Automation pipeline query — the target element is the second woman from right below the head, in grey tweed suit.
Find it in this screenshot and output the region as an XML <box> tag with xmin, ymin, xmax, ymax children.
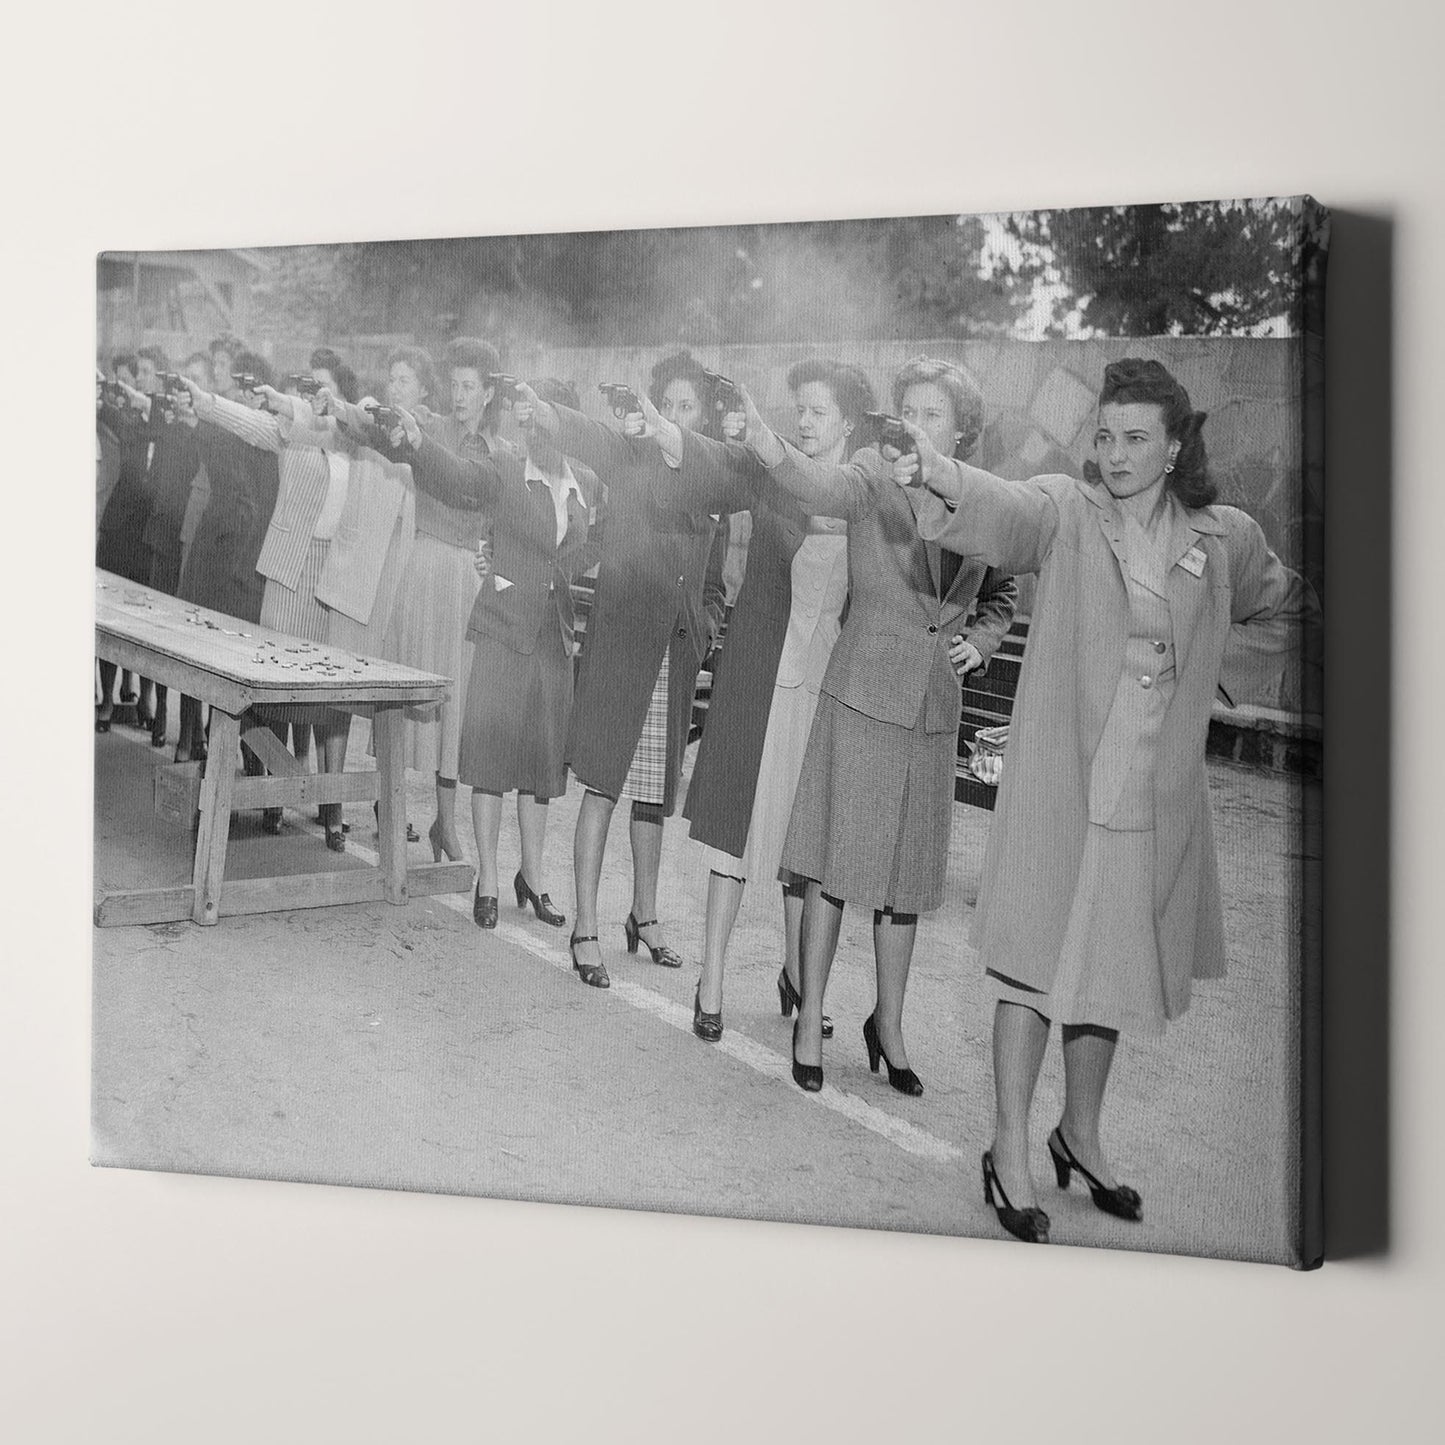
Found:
<box><xmin>743</xmin><ymin>369</ymin><xmax>1012</xmax><ymax>1094</ymax></box>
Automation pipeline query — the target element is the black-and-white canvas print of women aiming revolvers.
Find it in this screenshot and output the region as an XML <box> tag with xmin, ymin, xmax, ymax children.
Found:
<box><xmin>92</xmin><ymin>197</ymin><xmax>1328</xmax><ymax>1266</ymax></box>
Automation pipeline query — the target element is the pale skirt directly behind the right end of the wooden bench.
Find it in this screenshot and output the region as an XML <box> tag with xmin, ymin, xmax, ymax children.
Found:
<box><xmin>381</xmin><ymin>532</ymin><xmax>481</xmax><ymax>777</ymax></box>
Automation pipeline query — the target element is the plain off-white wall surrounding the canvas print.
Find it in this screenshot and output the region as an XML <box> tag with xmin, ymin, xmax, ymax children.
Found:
<box><xmin>14</xmin><ymin>0</ymin><xmax>1445</xmax><ymax>1445</ymax></box>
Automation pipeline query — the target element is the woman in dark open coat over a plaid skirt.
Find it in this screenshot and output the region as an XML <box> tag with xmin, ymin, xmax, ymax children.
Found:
<box><xmin>516</xmin><ymin>355</ymin><xmax>737</xmax><ymax>988</ymax></box>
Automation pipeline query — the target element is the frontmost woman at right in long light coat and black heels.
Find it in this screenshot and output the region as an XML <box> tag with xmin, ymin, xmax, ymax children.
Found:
<box><xmin>894</xmin><ymin>358</ymin><xmax>1314</xmax><ymax>1243</ymax></box>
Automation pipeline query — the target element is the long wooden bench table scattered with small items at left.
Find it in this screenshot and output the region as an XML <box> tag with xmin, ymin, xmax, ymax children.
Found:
<box><xmin>95</xmin><ymin>572</ymin><xmax>473</xmax><ymax>926</ymax></box>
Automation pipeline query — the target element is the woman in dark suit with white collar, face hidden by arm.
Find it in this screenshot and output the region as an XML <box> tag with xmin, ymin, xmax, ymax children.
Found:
<box><xmin>390</xmin><ymin>383</ymin><xmax>598</xmax><ymax>928</ymax></box>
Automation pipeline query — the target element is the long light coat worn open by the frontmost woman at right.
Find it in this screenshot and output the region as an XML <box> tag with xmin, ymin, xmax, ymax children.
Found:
<box><xmin>916</xmin><ymin>462</ymin><xmax>1318</xmax><ymax>1017</ymax></box>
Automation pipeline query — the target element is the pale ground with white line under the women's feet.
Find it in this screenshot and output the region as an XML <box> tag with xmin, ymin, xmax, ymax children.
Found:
<box><xmin>84</xmin><ymin>713</ymin><xmax>1301</xmax><ymax>1261</ymax></box>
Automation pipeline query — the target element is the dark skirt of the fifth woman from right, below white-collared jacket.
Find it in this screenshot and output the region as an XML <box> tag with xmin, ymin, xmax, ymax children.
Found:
<box><xmin>458</xmin><ymin>627</ymin><xmax>572</xmax><ymax>801</ymax></box>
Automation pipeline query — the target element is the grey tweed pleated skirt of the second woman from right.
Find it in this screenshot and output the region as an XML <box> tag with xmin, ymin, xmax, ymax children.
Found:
<box><xmin>782</xmin><ymin>692</ymin><xmax>958</xmax><ymax>913</ymax></box>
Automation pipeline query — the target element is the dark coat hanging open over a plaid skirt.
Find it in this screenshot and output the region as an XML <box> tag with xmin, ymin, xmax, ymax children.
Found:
<box><xmin>555</xmin><ymin>406</ymin><xmax>737</xmax><ymax>814</ymax></box>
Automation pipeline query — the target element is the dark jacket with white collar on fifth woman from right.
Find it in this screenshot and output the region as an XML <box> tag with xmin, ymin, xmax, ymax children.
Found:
<box><xmin>412</xmin><ymin>434</ymin><xmax>598</xmax><ymax>657</ymax></box>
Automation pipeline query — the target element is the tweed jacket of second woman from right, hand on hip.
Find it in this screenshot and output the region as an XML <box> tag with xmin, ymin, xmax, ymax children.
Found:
<box><xmin>772</xmin><ymin>442</ymin><xmax>1013</xmax><ymax>733</ymax></box>
